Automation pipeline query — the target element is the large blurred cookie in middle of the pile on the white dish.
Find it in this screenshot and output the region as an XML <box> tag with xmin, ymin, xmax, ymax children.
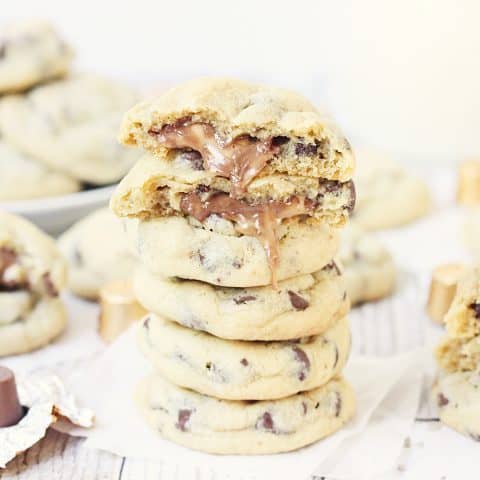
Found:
<box><xmin>0</xmin><ymin>74</ymin><xmax>137</xmax><ymax>185</ymax></box>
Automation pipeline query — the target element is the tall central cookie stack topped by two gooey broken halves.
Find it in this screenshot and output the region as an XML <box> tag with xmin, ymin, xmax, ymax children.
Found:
<box><xmin>111</xmin><ymin>79</ymin><xmax>355</xmax><ymax>454</ymax></box>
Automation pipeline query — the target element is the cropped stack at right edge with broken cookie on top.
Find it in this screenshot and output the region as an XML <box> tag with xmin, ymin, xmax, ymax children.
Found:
<box><xmin>433</xmin><ymin>267</ymin><xmax>480</xmax><ymax>441</ymax></box>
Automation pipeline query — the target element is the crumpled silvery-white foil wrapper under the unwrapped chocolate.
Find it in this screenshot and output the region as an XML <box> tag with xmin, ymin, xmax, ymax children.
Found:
<box><xmin>0</xmin><ymin>375</ymin><xmax>95</xmax><ymax>468</ymax></box>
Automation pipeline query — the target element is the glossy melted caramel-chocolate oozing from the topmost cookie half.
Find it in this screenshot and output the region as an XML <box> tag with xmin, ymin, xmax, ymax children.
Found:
<box><xmin>150</xmin><ymin>124</ymin><xmax>280</xmax><ymax>198</ymax></box>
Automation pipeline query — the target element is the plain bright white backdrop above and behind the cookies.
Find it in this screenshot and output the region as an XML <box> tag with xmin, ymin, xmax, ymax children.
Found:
<box><xmin>0</xmin><ymin>0</ymin><xmax>480</xmax><ymax>163</ymax></box>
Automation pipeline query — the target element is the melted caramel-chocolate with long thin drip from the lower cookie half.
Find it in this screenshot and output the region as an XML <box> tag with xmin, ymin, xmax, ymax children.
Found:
<box><xmin>180</xmin><ymin>192</ymin><xmax>314</xmax><ymax>288</ymax></box>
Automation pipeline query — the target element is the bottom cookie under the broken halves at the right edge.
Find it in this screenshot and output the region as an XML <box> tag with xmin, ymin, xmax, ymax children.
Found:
<box><xmin>433</xmin><ymin>370</ymin><xmax>480</xmax><ymax>442</ymax></box>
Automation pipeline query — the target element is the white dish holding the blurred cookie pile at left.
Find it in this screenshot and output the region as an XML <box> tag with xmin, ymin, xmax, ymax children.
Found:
<box><xmin>0</xmin><ymin>185</ymin><xmax>116</xmax><ymax>235</ymax></box>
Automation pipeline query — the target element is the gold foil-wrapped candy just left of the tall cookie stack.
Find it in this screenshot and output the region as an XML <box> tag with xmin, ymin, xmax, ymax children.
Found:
<box><xmin>98</xmin><ymin>281</ymin><xmax>147</xmax><ymax>343</ymax></box>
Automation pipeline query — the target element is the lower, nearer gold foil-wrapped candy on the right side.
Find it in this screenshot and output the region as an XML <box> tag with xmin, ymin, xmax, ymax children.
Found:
<box><xmin>427</xmin><ymin>263</ymin><xmax>465</xmax><ymax>324</ymax></box>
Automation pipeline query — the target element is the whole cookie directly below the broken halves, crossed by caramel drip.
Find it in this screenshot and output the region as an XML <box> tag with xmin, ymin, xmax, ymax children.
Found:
<box><xmin>124</xmin><ymin>215</ymin><xmax>339</xmax><ymax>287</ymax></box>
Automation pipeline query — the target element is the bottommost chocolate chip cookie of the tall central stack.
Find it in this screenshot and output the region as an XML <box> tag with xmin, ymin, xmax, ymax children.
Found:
<box><xmin>137</xmin><ymin>375</ymin><xmax>355</xmax><ymax>455</ymax></box>
